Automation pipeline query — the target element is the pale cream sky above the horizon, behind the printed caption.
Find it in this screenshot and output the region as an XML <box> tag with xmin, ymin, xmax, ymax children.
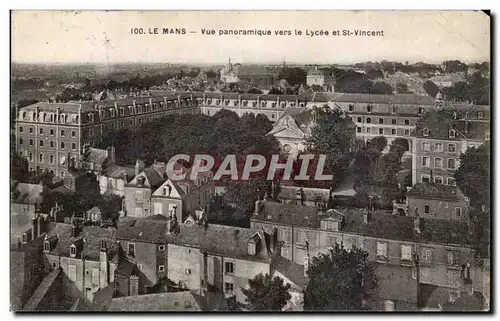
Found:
<box><xmin>11</xmin><ymin>10</ymin><xmax>490</xmax><ymax>64</ymax></box>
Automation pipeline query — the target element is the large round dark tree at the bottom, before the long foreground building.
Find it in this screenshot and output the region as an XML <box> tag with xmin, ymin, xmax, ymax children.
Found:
<box><xmin>304</xmin><ymin>244</ymin><xmax>377</xmax><ymax>311</ymax></box>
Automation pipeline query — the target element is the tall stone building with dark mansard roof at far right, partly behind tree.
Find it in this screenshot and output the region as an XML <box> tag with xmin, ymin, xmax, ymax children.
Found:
<box><xmin>411</xmin><ymin>105</ymin><xmax>491</xmax><ymax>185</ymax></box>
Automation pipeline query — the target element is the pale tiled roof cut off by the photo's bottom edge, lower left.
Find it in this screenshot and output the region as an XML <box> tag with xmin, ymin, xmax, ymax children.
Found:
<box><xmin>107</xmin><ymin>291</ymin><xmax>202</xmax><ymax>312</ymax></box>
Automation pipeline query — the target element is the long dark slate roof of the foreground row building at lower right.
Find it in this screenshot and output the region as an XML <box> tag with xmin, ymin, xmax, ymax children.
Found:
<box><xmin>250</xmin><ymin>201</ymin><xmax>472</xmax><ymax>245</ymax></box>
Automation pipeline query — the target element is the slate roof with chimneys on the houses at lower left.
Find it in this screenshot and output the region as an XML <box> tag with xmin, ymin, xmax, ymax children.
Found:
<box><xmin>47</xmin><ymin>222</ymin><xmax>119</xmax><ymax>261</ymax></box>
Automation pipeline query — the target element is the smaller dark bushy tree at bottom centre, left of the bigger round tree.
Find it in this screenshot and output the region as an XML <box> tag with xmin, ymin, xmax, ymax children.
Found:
<box><xmin>241</xmin><ymin>273</ymin><xmax>291</xmax><ymax>311</ymax></box>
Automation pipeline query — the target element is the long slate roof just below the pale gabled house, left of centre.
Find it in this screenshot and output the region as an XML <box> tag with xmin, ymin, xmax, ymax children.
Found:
<box><xmin>117</xmin><ymin>219</ymin><xmax>270</xmax><ymax>261</ymax></box>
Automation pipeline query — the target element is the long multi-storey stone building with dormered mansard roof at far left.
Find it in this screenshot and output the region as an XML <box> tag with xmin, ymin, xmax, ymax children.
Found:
<box><xmin>15</xmin><ymin>94</ymin><xmax>199</xmax><ymax>178</ymax></box>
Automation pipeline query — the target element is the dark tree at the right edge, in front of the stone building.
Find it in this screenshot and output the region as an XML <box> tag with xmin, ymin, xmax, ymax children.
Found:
<box><xmin>455</xmin><ymin>145</ymin><xmax>491</xmax><ymax>208</ymax></box>
